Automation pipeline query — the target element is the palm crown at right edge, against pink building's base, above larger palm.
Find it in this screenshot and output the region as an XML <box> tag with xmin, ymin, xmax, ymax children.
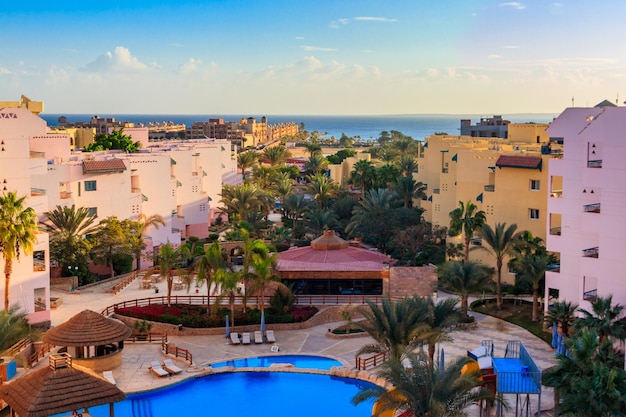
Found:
<box><xmin>574</xmin><ymin>295</ymin><xmax>626</xmax><ymax>342</ymax></box>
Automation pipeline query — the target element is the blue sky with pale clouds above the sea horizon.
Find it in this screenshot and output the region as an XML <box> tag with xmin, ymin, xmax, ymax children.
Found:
<box><xmin>0</xmin><ymin>0</ymin><xmax>626</xmax><ymax>115</ymax></box>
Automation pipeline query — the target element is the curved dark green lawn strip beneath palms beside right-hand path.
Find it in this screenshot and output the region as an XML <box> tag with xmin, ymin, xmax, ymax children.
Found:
<box><xmin>472</xmin><ymin>299</ymin><xmax>552</xmax><ymax>344</ymax></box>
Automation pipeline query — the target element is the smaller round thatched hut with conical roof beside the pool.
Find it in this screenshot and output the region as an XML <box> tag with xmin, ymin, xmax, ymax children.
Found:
<box><xmin>43</xmin><ymin>310</ymin><xmax>133</xmax><ymax>359</ymax></box>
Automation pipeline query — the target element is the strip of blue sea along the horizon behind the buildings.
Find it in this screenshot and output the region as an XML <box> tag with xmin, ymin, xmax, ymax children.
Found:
<box><xmin>40</xmin><ymin>113</ymin><xmax>558</xmax><ymax>141</ymax></box>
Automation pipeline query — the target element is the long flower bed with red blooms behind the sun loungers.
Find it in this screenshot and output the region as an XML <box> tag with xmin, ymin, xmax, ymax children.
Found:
<box><xmin>115</xmin><ymin>304</ymin><xmax>318</xmax><ymax>328</ymax></box>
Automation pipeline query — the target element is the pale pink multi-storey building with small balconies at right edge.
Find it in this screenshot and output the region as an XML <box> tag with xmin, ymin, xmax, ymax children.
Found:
<box><xmin>545</xmin><ymin>102</ymin><xmax>626</xmax><ymax>309</ymax></box>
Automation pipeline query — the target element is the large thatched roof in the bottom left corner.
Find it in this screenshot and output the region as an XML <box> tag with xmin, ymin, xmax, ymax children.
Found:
<box><xmin>0</xmin><ymin>354</ymin><xmax>126</xmax><ymax>417</ymax></box>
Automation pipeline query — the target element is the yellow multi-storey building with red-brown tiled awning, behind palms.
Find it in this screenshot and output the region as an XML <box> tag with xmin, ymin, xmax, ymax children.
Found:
<box><xmin>416</xmin><ymin>123</ymin><xmax>562</xmax><ymax>283</ymax></box>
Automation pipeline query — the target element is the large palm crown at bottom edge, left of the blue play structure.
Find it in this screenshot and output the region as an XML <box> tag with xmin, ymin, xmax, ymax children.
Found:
<box><xmin>352</xmin><ymin>353</ymin><xmax>495</xmax><ymax>417</ymax></box>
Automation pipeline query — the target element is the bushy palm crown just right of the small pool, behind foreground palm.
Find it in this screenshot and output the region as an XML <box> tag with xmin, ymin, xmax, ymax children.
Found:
<box><xmin>352</xmin><ymin>297</ymin><xmax>430</xmax><ymax>360</ymax></box>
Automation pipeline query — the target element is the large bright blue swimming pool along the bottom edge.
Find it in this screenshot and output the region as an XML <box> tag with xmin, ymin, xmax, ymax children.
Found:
<box><xmin>66</xmin><ymin>372</ymin><xmax>373</xmax><ymax>417</ymax></box>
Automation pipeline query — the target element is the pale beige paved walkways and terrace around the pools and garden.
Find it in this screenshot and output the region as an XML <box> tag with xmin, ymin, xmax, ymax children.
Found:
<box><xmin>51</xmin><ymin>274</ymin><xmax>556</xmax><ymax>412</ymax></box>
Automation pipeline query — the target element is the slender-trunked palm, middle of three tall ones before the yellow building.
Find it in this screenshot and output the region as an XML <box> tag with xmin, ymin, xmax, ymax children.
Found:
<box><xmin>478</xmin><ymin>223</ymin><xmax>521</xmax><ymax>310</ymax></box>
